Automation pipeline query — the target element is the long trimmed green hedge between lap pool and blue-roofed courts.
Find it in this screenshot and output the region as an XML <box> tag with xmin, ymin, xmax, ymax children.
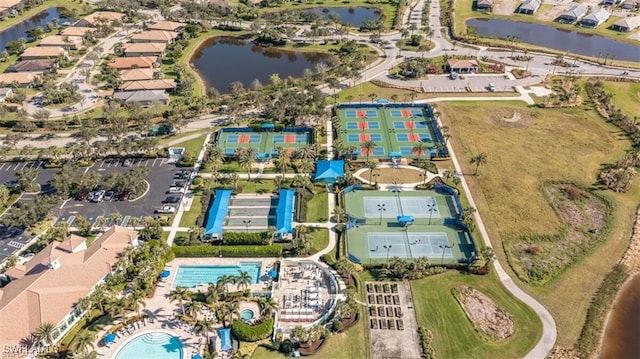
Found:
<box><xmin>173</xmin><ymin>244</ymin><xmax>282</xmax><ymax>257</ymax></box>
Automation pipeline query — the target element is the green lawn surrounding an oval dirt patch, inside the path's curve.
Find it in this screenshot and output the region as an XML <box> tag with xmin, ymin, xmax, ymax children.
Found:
<box><xmin>411</xmin><ymin>271</ymin><xmax>542</xmax><ymax>358</ymax></box>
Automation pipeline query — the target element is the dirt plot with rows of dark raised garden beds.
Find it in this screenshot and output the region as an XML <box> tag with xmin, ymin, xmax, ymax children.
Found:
<box><xmin>366</xmin><ymin>282</ymin><xmax>422</xmax><ymax>359</ymax></box>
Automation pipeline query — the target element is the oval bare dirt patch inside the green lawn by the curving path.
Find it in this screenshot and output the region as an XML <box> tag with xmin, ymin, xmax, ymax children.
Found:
<box><xmin>455</xmin><ymin>286</ymin><xmax>514</xmax><ymax>340</ymax></box>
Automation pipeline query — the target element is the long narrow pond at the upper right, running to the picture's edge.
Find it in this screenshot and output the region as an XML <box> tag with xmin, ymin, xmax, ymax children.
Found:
<box><xmin>466</xmin><ymin>19</ymin><xmax>640</xmax><ymax>62</ymax></box>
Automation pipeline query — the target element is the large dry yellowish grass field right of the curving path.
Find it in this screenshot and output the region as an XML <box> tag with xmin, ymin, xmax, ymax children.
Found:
<box><xmin>438</xmin><ymin>93</ymin><xmax>640</xmax><ymax>347</ymax></box>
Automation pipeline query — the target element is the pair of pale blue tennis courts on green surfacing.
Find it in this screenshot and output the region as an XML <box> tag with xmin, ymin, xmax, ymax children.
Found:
<box><xmin>344</xmin><ymin>191</ymin><xmax>474</xmax><ymax>264</ymax></box>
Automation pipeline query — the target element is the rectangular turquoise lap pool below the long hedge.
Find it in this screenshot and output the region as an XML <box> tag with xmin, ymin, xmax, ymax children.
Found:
<box><xmin>173</xmin><ymin>262</ymin><xmax>262</xmax><ymax>288</ymax></box>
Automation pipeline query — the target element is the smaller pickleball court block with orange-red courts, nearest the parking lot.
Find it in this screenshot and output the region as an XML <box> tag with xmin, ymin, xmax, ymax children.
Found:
<box><xmin>216</xmin><ymin>128</ymin><xmax>312</xmax><ymax>159</ymax></box>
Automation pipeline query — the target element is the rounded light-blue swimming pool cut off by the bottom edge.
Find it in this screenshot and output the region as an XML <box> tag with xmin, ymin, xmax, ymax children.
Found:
<box><xmin>113</xmin><ymin>330</ymin><xmax>184</xmax><ymax>359</ymax></box>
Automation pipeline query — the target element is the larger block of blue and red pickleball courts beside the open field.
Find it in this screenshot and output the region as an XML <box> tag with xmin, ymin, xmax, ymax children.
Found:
<box><xmin>337</xmin><ymin>104</ymin><xmax>448</xmax><ymax>158</ymax></box>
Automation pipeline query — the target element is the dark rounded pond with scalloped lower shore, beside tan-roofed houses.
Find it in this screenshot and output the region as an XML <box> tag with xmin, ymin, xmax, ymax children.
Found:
<box><xmin>191</xmin><ymin>37</ymin><xmax>329</xmax><ymax>93</ymax></box>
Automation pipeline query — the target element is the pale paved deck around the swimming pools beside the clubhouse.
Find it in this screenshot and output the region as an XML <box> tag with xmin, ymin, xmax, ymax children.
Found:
<box><xmin>95</xmin><ymin>258</ymin><xmax>276</xmax><ymax>359</ymax></box>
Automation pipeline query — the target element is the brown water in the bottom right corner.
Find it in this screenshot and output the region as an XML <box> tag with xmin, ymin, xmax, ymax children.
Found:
<box><xmin>600</xmin><ymin>275</ymin><xmax>640</xmax><ymax>359</ymax></box>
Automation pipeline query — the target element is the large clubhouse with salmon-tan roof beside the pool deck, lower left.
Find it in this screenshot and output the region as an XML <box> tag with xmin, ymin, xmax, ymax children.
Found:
<box><xmin>0</xmin><ymin>226</ymin><xmax>138</xmax><ymax>345</ymax></box>
